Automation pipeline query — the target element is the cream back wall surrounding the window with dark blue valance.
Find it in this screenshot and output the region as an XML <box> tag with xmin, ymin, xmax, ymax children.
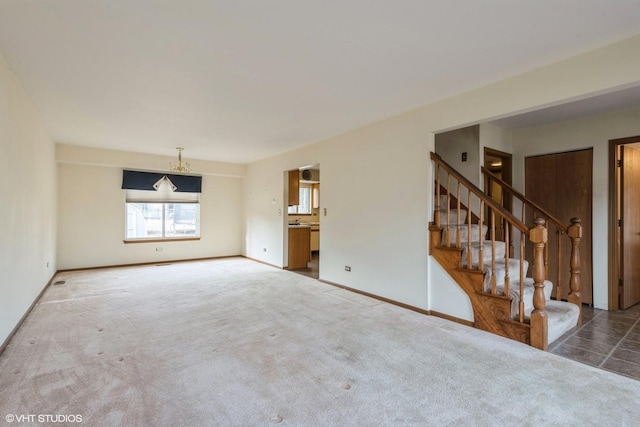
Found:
<box><xmin>57</xmin><ymin>145</ymin><xmax>245</xmax><ymax>270</ymax></box>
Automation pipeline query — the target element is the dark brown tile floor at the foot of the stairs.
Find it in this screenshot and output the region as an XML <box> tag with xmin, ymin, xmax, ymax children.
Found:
<box><xmin>549</xmin><ymin>304</ymin><xmax>640</xmax><ymax>380</ymax></box>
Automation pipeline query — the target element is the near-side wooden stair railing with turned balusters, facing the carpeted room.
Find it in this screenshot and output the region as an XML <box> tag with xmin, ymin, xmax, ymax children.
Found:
<box><xmin>430</xmin><ymin>152</ymin><xmax>547</xmax><ymax>328</ymax></box>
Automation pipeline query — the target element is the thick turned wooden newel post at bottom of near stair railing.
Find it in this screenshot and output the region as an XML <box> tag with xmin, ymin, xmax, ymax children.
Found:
<box><xmin>529</xmin><ymin>218</ymin><xmax>549</xmax><ymax>351</ymax></box>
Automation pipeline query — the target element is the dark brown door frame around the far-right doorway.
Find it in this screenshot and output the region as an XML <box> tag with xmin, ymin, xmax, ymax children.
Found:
<box><xmin>608</xmin><ymin>135</ymin><xmax>640</xmax><ymax>311</ymax></box>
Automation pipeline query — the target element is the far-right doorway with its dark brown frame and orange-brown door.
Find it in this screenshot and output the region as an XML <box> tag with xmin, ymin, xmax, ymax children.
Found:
<box><xmin>609</xmin><ymin>136</ymin><xmax>640</xmax><ymax>310</ymax></box>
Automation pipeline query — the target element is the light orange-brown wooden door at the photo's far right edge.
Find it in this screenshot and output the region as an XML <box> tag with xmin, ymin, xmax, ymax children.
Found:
<box><xmin>620</xmin><ymin>145</ymin><xmax>640</xmax><ymax>309</ymax></box>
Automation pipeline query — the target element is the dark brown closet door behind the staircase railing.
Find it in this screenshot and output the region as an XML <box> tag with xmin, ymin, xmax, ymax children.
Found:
<box><xmin>525</xmin><ymin>149</ymin><xmax>593</xmax><ymax>304</ymax></box>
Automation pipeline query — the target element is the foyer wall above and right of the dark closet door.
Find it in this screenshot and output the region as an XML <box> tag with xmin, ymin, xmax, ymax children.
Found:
<box><xmin>513</xmin><ymin>105</ymin><xmax>640</xmax><ymax>309</ymax></box>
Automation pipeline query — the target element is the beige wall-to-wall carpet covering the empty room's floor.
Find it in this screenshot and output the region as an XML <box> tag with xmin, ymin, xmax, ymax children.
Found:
<box><xmin>0</xmin><ymin>258</ymin><xmax>640</xmax><ymax>426</ymax></box>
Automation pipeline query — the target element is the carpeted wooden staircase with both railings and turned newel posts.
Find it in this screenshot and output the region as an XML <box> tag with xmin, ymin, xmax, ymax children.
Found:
<box><xmin>429</xmin><ymin>153</ymin><xmax>582</xmax><ymax>350</ymax></box>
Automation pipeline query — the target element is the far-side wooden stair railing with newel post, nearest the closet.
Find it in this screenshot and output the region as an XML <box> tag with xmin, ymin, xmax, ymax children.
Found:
<box><xmin>481</xmin><ymin>166</ymin><xmax>582</xmax><ymax>324</ymax></box>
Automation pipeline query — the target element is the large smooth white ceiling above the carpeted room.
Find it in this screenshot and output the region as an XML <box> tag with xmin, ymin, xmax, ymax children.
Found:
<box><xmin>0</xmin><ymin>0</ymin><xmax>640</xmax><ymax>163</ymax></box>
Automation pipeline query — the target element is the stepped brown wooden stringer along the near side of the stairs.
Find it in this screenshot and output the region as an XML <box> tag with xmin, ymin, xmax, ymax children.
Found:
<box><xmin>431</xmin><ymin>247</ymin><xmax>531</xmax><ymax>345</ymax></box>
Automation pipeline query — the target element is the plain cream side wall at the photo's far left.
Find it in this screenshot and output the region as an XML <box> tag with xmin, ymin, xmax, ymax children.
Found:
<box><xmin>0</xmin><ymin>55</ymin><xmax>56</xmax><ymax>345</ymax></box>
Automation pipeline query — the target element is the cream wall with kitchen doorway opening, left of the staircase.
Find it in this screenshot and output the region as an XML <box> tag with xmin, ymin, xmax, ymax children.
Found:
<box><xmin>245</xmin><ymin>116</ymin><xmax>429</xmax><ymax>307</ymax></box>
